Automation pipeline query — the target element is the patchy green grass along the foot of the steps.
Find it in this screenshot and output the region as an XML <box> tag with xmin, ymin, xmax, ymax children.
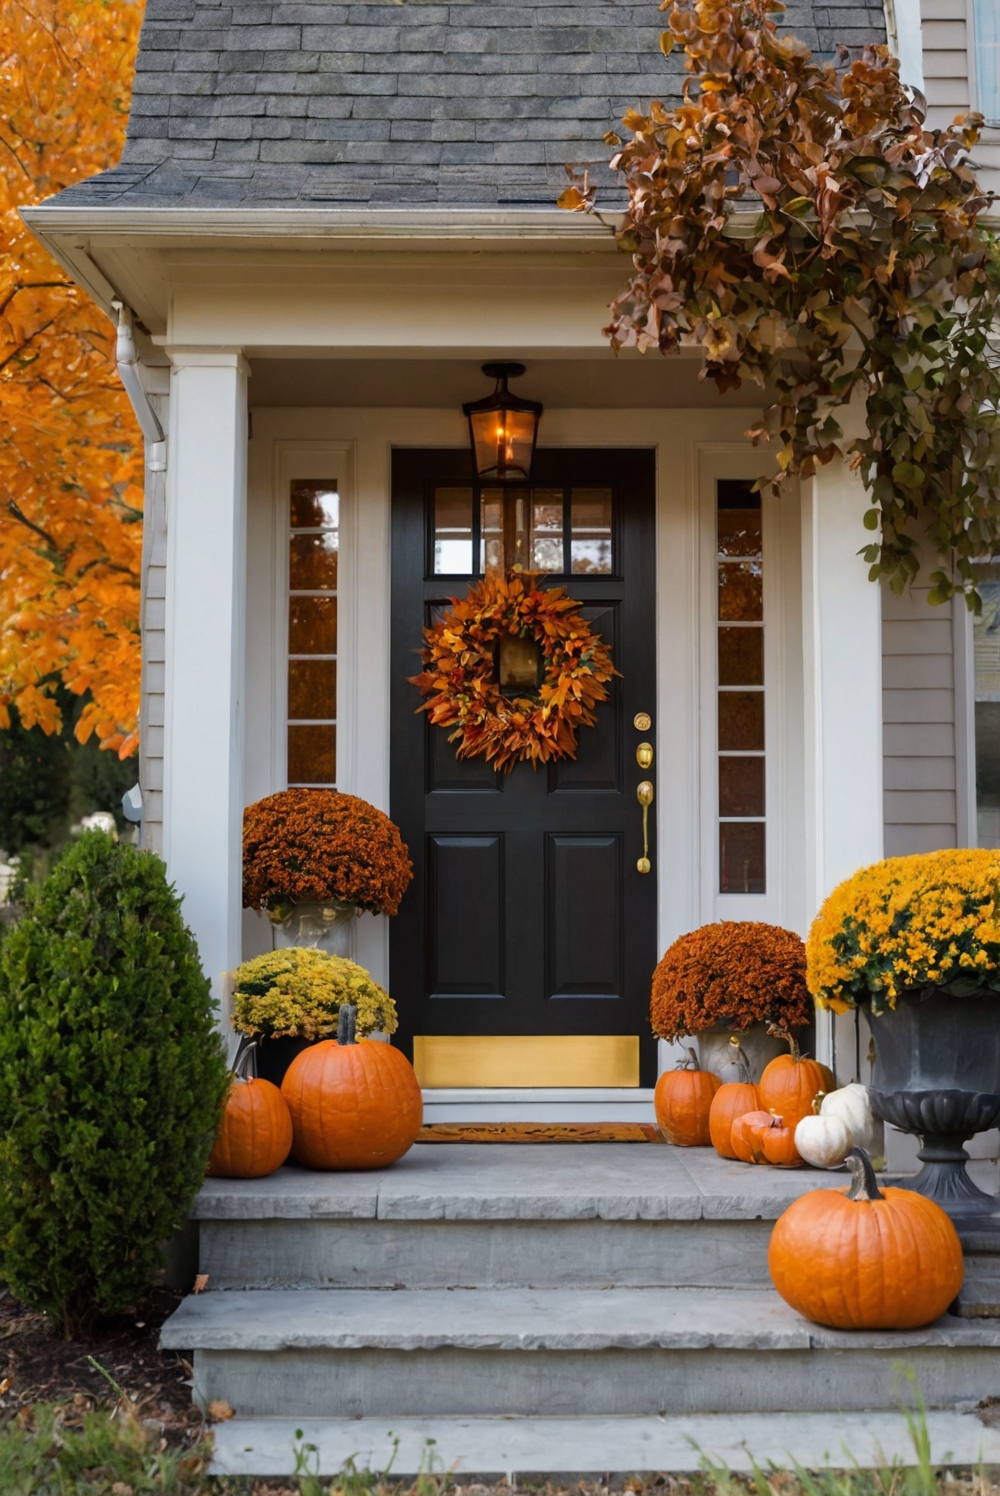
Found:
<box><xmin>0</xmin><ymin>1388</ymin><xmax>1000</xmax><ymax>1496</ymax></box>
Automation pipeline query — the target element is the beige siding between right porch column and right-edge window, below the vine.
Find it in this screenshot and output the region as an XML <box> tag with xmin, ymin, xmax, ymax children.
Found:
<box><xmin>882</xmin><ymin>588</ymin><xmax>958</xmax><ymax>857</ymax></box>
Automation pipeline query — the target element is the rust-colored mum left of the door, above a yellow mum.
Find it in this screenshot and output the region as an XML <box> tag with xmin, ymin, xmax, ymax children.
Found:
<box><xmin>243</xmin><ymin>790</ymin><xmax>413</xmax><ymax>914</ymax></box>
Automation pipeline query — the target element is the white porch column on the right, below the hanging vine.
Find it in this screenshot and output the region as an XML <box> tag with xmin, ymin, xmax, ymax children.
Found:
<box><xmin>802</xmin><ymin>459</ymin><xmax>883</xmax><ymax>1083</ymax></box>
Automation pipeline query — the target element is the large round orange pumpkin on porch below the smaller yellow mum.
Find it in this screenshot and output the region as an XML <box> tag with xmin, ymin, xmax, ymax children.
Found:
<box><xmin>281</xmin><ymin>1004</ymin><xmax>424</xmax><ymax>1168</ymax></box>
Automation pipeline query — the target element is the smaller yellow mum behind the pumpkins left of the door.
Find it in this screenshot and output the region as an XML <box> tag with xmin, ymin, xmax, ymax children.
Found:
<box><xmin>232</xmin><ymin>945</ymin><xmax>398</xmax><ymax>1040</ymax></box>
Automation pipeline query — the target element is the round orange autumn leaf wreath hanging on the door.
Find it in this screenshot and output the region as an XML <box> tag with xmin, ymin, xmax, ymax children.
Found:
<box><xmin>409</xmin><ymin>571</ymin><xmax>618</xmax><ymax>773</ymax></box>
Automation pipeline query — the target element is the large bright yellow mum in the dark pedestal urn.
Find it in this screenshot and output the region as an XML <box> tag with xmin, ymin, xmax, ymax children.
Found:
<box><xmin>805</xmin><ymin>848</ymin><xmax>1000</xmax><ymax>1013</ymax></box>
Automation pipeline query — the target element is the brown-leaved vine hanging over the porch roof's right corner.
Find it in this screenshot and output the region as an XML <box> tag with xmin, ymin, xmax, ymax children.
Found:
<box><xmin>560</xmin><ymin>0</ymin><xmax>1000</xmax><ymax>606</ymax></box>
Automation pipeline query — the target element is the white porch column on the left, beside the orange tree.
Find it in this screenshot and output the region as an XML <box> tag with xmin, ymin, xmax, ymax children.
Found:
<box><xmin>163</xmin><ymin>349</ymin><xmax>249</xmax><ymax>1020</ymax></box>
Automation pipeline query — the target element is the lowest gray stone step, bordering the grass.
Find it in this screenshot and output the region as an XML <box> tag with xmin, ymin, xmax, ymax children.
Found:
<box><xmin>211</xmin><ymin>1411</ymin><xmax>1000</xmax><ymax>1484</ymax></box>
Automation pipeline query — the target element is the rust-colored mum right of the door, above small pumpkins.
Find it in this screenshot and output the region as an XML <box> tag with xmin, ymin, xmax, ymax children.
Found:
<box><xmin>650</xmin><ymin>920</ymin><xmax>813</xmax><ymax>1040</ymax></box>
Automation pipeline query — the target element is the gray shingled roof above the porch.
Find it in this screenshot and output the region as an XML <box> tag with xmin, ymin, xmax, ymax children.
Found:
<box><xmin>50</xmin><ymin>0</ymin><xmax>885</xmax><ymax>208</ymax></box>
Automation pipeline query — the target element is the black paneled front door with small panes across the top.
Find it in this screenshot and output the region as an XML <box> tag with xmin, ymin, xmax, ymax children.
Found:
<box><xmin>391</xmin><ymin>449</ymin><xmax>656</xmax><ymax>1085</ymax></box>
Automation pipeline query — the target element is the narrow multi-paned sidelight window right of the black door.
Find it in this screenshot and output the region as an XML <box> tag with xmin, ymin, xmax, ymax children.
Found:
<box><xmin>716</xmin><ymin>479</ymin><xmax>766</xmax><ymax>893</ymax></box>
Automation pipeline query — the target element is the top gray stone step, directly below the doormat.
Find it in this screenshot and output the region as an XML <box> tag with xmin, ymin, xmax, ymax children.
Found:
<box><xmin>195</xmin><ymin>1144</ymin><xmax>843</xmax><ymax>1288</ymax></box>
